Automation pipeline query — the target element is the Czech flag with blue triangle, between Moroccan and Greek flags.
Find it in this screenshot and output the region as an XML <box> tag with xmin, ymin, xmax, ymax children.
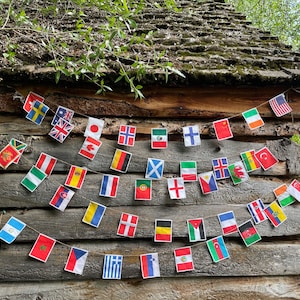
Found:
<box><xmin>64</xmin><ymin>247</ymin><xmax>88</xmax><ymax>275</ymax></box>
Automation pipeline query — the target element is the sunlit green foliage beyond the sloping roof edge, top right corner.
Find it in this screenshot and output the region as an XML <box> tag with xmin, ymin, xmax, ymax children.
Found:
<box><xmin>226</xmin><ymin>0</ymin><xmax>300</xmax><ymax>50</ymax></box>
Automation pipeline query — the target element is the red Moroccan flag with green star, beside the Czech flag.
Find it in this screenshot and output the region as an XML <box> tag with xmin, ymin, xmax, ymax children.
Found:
<box><xmin>29</xmin><ymin>233</ymin><xmax>56</xmax><ymax>262</ymax></box>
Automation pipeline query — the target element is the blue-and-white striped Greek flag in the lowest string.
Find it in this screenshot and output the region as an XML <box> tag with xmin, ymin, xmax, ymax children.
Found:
<box><xmin>102</xmin><ymin>254</ymin><xmax>123</xmax><ymax>279</ymax></box>
